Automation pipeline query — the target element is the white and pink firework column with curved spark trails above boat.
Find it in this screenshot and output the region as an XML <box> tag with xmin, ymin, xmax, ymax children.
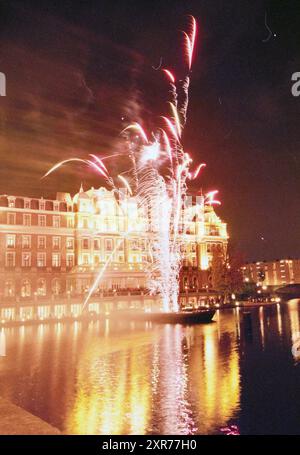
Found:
<box><xmin>45</xmin><ymin>17</ymin><xmax>211</xmax><ymax>311</ymax></box>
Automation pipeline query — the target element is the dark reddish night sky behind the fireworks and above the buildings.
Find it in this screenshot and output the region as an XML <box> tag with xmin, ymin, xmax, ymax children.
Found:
<box><xmin>0</xmin><ymin>0</ymin><xmax>300</xmax><ymax>260</ymax></box>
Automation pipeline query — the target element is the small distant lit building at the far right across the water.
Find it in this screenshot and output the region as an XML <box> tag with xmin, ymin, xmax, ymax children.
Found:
<box><xmin>242</xmin><ymin>259</ymin><xmax>300</xmax><ymax>287</ymax></box>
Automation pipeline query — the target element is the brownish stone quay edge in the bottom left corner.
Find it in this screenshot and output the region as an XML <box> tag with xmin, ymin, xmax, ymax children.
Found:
<box><xmin>0</xmin><ymin>398</ymin><xmax>61</xmax><ymax>435</ymax></box>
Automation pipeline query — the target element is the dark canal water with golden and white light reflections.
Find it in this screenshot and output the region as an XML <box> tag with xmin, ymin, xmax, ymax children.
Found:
<box><xmin>0</xmin><ymin>300</ymin><xmax>300</xmax><ymax>434</ymax></box>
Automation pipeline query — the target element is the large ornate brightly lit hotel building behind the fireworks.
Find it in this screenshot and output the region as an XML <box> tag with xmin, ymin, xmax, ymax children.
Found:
<box><xmin>0</xmin><ymin>188</ymin><xmax>227</xmax><ymax>301</ymax></box>
